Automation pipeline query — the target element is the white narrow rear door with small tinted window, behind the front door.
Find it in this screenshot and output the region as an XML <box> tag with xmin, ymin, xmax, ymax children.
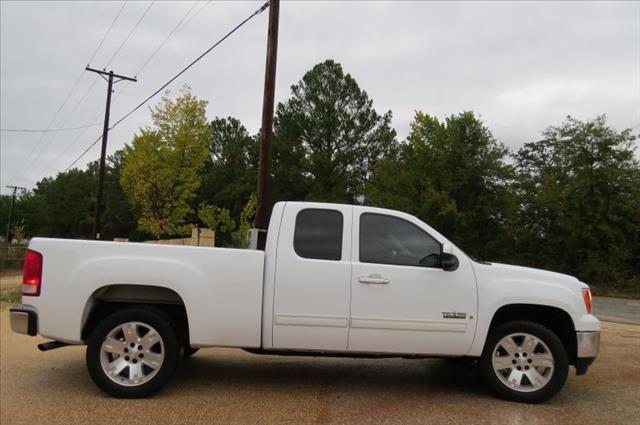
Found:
<box><xmin>273</xmin><ymin>202</ymin><xmax>353</xmax><ymax>351</ymax></box>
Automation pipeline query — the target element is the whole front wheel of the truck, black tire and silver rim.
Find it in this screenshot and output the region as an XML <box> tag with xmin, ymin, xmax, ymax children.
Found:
<box><xmin>480</xmin><ymin>321</ymin><xmax>569</xmax><ymax>403</ymax></box>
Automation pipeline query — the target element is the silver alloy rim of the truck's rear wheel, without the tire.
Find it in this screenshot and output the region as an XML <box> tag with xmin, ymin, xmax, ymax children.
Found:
<box><xmin>100</xmin><ymin>322</ymin><xmax>165</xmax><ymax>387</ymax></box>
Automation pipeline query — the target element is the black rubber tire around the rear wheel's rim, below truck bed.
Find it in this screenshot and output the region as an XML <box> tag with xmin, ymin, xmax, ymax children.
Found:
<box><xmin>86</xmin><ymin>307</ymin><xmax>180</xmax><ymax>398</ymax></box>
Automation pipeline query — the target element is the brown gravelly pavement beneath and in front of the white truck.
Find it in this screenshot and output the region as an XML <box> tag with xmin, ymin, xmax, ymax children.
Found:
<box><xmin>0</xmin><ymin>306</ymin><xmax>640</xmax><ymax>425</ymax></box>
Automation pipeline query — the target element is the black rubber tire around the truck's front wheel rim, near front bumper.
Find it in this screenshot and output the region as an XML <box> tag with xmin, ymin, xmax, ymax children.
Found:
<box><xmin>480</xmin><ymin>321</ymin><xmax>569</xmax><ymax>403</ymax></box>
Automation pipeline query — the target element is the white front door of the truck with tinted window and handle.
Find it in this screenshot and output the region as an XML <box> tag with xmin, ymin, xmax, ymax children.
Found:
<box><xmin>348</xmin><ymin>207</ymin><xmax>477</xmax><ymax>355</ymax></box>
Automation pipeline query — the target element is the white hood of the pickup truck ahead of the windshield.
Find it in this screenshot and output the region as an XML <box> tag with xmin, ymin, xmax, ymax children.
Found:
<box><xmin>473</xmin><ymin>263</ymin><xmax>587</xmax><ymax>289</ymax></box>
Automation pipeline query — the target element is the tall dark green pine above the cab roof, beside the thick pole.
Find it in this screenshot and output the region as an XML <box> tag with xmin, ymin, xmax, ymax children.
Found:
<box><xmin>273</xmin><ymin>60</ymin><xmax>396</xmax><ymax>203</ymax></box>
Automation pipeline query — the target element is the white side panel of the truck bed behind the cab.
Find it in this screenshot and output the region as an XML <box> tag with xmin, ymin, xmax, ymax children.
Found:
<box><xmin>23</xmin><ymin>238</ymin><xmax>264</xmax><ymax>347</ymax></box>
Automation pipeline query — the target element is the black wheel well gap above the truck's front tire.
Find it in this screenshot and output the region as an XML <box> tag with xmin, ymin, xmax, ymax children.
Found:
<box><xmin>485</xmin><ymin>304</ymin><xmax>577</xmax><ymax>365</ymax></box>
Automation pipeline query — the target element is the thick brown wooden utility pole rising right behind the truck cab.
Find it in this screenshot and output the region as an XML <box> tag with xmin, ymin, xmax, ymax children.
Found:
<box><xmin>256</xmin><ymin>0</ymin><xmax>280</xmax><ymax>250</ymax></box>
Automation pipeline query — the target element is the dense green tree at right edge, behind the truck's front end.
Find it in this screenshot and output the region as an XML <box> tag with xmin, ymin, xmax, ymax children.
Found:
<box><xmin>514</xmin><ymin>115</ymin><xmax>640</xmax><ymax>291</ymax></box>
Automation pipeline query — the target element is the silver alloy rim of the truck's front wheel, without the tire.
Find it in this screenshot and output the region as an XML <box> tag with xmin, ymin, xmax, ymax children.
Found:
<box><xmin>491</xmin><ymin>333</ymin><xmax>554</xmax><ymax>392</ymax></box>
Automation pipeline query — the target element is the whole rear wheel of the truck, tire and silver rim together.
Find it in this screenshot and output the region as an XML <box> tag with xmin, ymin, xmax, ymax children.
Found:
<box><xmin>86</xmin><ymin>308</ymin><xmax>180</xmax><ymax>398</ymax></box>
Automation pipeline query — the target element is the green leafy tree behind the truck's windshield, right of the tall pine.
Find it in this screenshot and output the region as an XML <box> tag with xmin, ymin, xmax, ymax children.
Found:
<box><xmin>366</xmin><ymin>112</ymin><xmax>515</xmax><ymax>259</ymax></box>
